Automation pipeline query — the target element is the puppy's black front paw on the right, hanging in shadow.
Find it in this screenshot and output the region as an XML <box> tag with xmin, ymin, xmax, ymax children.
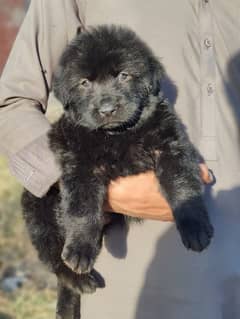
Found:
<box><xmin>176</xmin><ymin>202</ymin><xmax>213</xmax><ymax>252</ymax></box>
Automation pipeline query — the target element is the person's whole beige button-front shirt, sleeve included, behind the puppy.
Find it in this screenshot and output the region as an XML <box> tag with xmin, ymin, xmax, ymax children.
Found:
<box><xmin>0</xmin><ymin>0</ymin><xmax>240</xmax><ymax>319</ymax></box>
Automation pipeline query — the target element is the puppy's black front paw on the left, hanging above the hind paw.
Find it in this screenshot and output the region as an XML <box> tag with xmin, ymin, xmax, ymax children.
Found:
<box><xmin>61</xmin><ymin>241</ymin><xmax>97</xmax><ymax>274</ymax></box>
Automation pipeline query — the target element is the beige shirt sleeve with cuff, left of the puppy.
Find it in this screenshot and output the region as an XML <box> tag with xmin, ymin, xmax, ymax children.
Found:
<box><xmin>0</xmin><ymin>0</ymin><xmax>83</xmax><ymax>197</ymax></box>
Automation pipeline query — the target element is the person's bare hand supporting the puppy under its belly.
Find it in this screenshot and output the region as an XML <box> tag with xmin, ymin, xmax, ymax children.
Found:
<box><xmin>104</xmin><ymin>164</ymin><xmax>213</xmax><ymax>221</ymax></box>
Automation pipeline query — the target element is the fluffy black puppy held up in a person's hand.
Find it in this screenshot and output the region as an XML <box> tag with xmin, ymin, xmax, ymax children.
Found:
<box><xmin>22</xmin><ymin>26</ymin><xmax>213</xmax><ymax>302</ymax></box>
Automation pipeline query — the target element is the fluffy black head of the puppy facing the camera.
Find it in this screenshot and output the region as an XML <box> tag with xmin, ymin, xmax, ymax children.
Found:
<box><xmin>53</xmin><ymin>26</ymin><xmax>164</xmax><ymax>131</ymax></box>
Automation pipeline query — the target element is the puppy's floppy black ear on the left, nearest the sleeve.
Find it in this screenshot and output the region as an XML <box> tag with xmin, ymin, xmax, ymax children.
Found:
<box><xmin>52</xmin><ymin>64</ymin><xmax>69</xmax><ymax>110</ymax></box>
